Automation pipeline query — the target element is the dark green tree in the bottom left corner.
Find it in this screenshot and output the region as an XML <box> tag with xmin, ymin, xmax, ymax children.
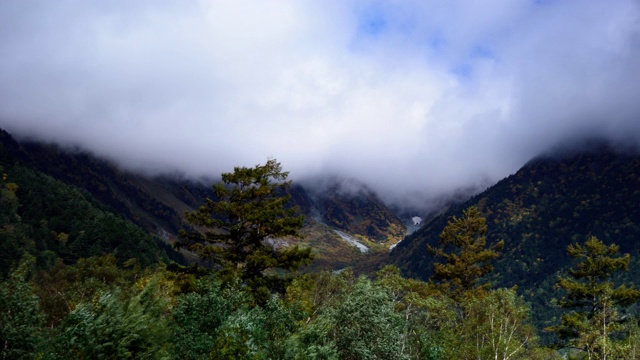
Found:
<box><xmin>0</xmin><ymin>256</ymin><xmax>44</xmax><ymax>359</ymax></box>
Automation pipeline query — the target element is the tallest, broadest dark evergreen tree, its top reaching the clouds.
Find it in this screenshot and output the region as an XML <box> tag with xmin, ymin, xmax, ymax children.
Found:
<box><xmin>181</xmin><ymin>159</ymin><xmax>311</xmax><ymax>303</ymax></box>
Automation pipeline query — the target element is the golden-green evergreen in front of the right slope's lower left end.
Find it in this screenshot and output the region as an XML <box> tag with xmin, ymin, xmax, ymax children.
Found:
<box><xmin>427</xmin><ymin>207</ymin><xmax>504</xmax><ymax>299</ymax></box>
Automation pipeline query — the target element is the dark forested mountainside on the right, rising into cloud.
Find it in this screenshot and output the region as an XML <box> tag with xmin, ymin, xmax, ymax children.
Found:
<box><xmin>390</xmin><ymin>144</ymin><xmax>640</xmax><ymax>336</ymax></box>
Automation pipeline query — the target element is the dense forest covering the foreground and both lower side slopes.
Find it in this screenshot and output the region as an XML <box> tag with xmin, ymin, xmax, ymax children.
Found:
<box><xmin>0</xmin><ymin>130</ymin><xmax>640</xmax><ymax>359</ymax></box>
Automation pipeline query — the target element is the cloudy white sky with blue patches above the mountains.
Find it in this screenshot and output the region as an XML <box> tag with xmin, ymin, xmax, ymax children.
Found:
<box><xmin>0</xmin><ymin>0</ymin><xmax>640</xmax><ymax>211</ymax></box>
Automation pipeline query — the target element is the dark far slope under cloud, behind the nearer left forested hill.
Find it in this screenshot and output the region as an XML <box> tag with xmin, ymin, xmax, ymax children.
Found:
<box><xmin>3</xmin><ymin>132</ymin><xmax>202</xmax><ymax>233</ymax></box>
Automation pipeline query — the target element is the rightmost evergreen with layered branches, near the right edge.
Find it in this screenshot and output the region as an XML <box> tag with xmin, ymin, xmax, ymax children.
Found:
<box><xmin>548</xmin><ymin>236</ymin><xmax>640</xmax><ymax>359</ymax></box>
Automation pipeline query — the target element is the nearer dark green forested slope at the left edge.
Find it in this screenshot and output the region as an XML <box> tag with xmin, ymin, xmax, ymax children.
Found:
<box><xmin>0</xmin><ymin>134</ymin><xmax>184</xmax><ymax>275</ymax></box>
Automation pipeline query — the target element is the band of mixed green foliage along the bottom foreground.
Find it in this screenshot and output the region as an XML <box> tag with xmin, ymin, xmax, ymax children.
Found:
<box><xmin>0</xmin><ymin>253</ymin><xmax>556</xmax><ymax>360</ymax></box>
